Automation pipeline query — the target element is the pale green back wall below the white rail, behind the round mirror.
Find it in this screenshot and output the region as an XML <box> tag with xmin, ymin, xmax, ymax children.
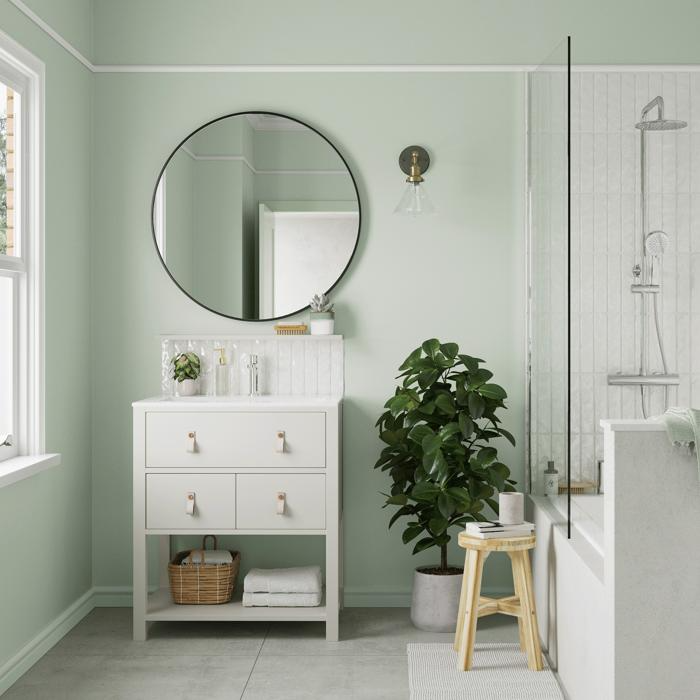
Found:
<box><xmin>93</xmin><ymin>69</ymin><xmax>524</xmax><ymax>602</ymax></box>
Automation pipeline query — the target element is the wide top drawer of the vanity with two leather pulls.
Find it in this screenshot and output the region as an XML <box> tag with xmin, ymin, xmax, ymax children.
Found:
<box><xmin>145</xmin><ymin>412</ymin><xmax>326</xmax><ymax>469</ymax></box>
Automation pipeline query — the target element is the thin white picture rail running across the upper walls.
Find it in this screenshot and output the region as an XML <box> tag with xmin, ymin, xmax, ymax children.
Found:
<box><xmin>9</xmin><ymin>0</ymin><xmax>700</xmax><ymax>73</ymax></box>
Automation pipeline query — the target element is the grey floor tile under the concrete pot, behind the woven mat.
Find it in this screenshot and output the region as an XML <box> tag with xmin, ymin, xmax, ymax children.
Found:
<box><xmin>261</xmin><ymin>608</ymin><xmax>518</xmax><ymax>656</ymax></box>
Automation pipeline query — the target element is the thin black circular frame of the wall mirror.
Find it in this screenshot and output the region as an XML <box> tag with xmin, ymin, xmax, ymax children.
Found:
<box><xmin>151</xmin><ymin>110</ymin><xmax>362</xmax><ymax>323</ymax></box>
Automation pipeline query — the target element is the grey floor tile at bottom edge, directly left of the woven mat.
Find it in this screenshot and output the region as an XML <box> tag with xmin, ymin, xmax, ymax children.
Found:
<box><xmin>243</xmin><ymin>655</ymin><xmax>408</xmax><ymax>700</ymax></box>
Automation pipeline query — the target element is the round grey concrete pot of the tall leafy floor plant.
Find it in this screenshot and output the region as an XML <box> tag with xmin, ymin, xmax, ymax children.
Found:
<box><xmin>411</xmin><ymin>567</ymin><xmax>462</xmax><ymax>632</ymax></box>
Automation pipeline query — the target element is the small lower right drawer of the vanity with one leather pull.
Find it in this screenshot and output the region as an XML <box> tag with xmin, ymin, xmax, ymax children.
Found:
<box><xmin>236</xmin><ymin>474</ymin><xmax>326</xmax><ymax>530</ymax></box>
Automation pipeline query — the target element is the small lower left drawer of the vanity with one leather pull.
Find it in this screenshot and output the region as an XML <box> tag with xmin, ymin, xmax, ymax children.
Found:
<box><xmin>146</xmin><ymin>474</ymin><xmax>236</xmax><ymax>530</ymax></box>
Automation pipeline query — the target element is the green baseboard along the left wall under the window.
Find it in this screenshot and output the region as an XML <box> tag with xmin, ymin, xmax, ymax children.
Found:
<box><xmin>0</xmin><ymin>589</ymin><xmax>94</xmax><ymax>695</ymax></box>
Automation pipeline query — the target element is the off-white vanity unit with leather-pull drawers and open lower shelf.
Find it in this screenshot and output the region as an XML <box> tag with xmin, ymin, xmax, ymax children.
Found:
<box><xmin>133</xmin><ymin>396</ymin><xmax>342</xmax><ymax>640</ymax></box>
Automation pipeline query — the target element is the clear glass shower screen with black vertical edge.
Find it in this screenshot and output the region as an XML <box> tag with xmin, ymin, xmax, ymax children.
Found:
<box><xmin>527</xmin><ymin>37</ymin><xmax>572</xmax><ymax>528</ymax></box>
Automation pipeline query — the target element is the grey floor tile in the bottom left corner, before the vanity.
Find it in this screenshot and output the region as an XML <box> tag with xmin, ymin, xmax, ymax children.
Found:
<box><xmin>3</xmin><ymin>655</ymin><xmax>255</xmax><ymax>700</ymax></box>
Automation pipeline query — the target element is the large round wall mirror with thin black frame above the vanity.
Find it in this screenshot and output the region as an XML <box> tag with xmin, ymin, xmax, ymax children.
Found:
<box><xmin>153</xmin><ymin>112</ymin><xmax>360</xmax><ymax>321</ymax></box>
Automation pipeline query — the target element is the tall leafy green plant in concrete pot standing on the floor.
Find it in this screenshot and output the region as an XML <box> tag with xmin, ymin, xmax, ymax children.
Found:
<box><xmin>375</xmin><ymin>338</ymin><xmax>515</xmax><ymax>632</ymax></box>
